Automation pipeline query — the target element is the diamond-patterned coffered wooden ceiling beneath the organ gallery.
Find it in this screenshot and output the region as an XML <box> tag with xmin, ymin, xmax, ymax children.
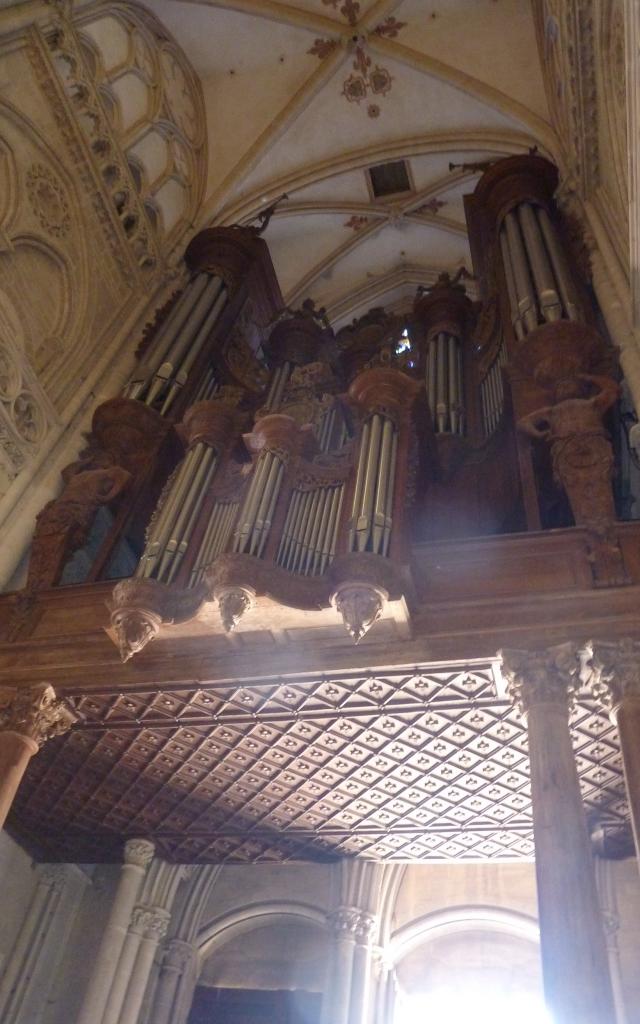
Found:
<box><xmin>14</xmin><ymin>662</ymin><xmax>628</xmax><ymax>863</ymax></box>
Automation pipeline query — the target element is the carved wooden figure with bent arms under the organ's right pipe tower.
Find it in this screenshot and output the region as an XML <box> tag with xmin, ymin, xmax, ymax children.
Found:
<box><xmin>518</xmin><ymin>374</ymin><xmax>618</xmax><ymax>530</ymax></box>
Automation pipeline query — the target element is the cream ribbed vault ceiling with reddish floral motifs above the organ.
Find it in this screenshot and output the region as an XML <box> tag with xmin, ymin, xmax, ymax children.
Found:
<box><xmin>143</xmin><ymin>0</ymin><xmax>558</xmax><ymax>327</ymax></box>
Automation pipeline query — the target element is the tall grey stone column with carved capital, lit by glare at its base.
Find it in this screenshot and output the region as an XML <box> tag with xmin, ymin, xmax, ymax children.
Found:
<box><xmin>503</xmin><ymin>644</ymin><xmax>615</xmax><ymax>1024</ymax></box>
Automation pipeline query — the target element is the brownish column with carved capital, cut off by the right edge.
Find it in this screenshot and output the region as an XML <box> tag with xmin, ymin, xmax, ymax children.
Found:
<box><xmin>591</xmin><ymin>639</ymin><xmax>640</xmax><ymax>864</ymax></box>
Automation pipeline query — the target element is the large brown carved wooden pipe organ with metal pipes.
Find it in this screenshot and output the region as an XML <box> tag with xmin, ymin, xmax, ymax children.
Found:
<box><xmin>23</xmin><ymin>156</ymin><xmax>624</xmax><ymax>656</ymax></box>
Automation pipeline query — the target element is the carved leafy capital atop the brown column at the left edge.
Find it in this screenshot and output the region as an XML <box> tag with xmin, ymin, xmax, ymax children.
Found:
<box><xmin>0</xmin><ymin>683</ymin><xmax>78</xmax><ymax>746</ymax></box>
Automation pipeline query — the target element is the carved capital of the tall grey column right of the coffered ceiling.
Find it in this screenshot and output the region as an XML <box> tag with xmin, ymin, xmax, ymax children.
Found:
<box><xmin>500</xmin><ymin>643</ymin><xmax>580</xmax><ymax>715</ymax></box>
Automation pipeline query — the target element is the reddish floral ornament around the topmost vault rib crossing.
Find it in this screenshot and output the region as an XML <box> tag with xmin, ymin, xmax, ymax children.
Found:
<box><xmin>307</xmin><ymin>14</ymin><xmax>406</xmax><ymax>118</ymax></box>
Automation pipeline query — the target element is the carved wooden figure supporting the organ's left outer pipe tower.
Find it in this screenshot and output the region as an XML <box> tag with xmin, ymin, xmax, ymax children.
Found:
<box><xmin>27</xmin><ymin>452</ymin><xmax>131</xmax><ymax>590</ymax></box>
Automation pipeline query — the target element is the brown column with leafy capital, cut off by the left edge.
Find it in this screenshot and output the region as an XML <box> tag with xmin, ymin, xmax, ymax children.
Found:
<box><xmin>0</xmin><ymin>683</ymin><xmax>76</xmax><ymax>828</ymax></box>
